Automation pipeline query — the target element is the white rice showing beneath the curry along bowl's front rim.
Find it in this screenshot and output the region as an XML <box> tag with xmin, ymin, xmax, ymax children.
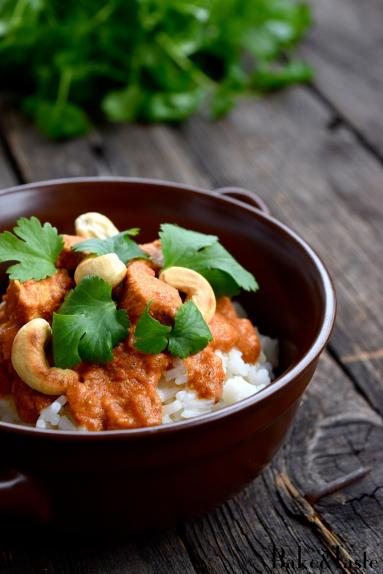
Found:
<box><xmin>0</xmin><ymin>335</ymin><xmax>278</xmax><ymax>431</ymax></box>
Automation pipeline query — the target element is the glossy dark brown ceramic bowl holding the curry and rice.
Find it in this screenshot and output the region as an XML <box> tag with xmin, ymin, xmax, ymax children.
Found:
<box><xmin>0</xmin><ymin>178</ymin><xmax>335</xmax><ymax>530</ymax></box>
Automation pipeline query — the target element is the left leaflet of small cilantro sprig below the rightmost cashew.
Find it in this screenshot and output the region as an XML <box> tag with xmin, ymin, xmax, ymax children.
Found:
<box><xmin>134</xmin><ymin>303</ymin><xmax>172</xmax><ymax>355</ymax></box>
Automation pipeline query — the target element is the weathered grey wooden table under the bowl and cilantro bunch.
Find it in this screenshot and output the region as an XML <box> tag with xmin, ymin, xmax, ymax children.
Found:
<box><xmin>0</xmin><ymin>0</ymin><xmax>383</xmax><ymax>574</ymax></box>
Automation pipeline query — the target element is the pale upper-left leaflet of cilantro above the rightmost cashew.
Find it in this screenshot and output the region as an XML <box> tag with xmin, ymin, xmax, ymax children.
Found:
<box><xmin>159</xmin><ymin>223</ymin><xmax>218</xmax><ymax>267</ymax></box>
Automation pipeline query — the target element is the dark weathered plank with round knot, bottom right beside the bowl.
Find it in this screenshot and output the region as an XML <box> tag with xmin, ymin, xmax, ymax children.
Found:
<box><xmin>183</xmin><ymin>358</ymin><xmax>383</xmax><ymax>574</ymax></box>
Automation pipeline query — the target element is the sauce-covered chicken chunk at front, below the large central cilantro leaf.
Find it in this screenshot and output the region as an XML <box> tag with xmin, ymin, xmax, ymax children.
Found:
<box><xmin>67</xmin><ymin>343</ymin><xmax>169</xmax><ymax>431</ymax></box>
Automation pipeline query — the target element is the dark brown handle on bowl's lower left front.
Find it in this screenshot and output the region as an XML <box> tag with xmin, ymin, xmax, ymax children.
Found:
<box><xmin>0</xmin><ymin>470</ymin><xmax>51</xmax><ymax>523</ymax></box>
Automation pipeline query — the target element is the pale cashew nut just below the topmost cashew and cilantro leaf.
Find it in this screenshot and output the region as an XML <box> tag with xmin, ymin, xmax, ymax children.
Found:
<box><xmin>74</xmin><ymin>253</ymin><xmax>126</xmax><ymax>287</ymax></box>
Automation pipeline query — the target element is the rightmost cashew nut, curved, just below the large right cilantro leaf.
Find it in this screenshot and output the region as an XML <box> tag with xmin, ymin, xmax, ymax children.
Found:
<box><xmin>160</xmin><ymin>267</ymin><xmax>216</xmax><ymax>323</ymax></box>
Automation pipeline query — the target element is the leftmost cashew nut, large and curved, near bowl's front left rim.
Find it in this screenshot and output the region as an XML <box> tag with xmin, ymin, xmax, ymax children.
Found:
<box><xmin>12</xmin><ymin>319</ymin><xmax>78</xmax><ymax>395</ymax></box>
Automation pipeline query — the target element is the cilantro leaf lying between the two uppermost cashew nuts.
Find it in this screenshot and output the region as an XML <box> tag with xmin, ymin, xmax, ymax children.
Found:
<box><xmin>72</xmin><ymin>227</ymin><xmax>148</xmax><ymax>263</ymax></box>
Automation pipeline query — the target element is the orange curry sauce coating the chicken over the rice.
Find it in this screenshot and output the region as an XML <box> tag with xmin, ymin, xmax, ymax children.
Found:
<box><xmin>0</xmin><ymin>236</ymin><xmax>260</xmax><ymax>431</ymax></box>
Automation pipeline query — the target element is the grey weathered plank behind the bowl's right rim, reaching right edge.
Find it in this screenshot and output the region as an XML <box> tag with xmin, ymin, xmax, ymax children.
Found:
<box><xmin>178</xmin><ymin>88</ymin><xmax>383</xmax><ymax>413</ymax></box>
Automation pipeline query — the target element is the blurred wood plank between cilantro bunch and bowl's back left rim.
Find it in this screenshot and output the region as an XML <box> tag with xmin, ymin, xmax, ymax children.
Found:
<box><xmin>0</xmin><ymin>110</ymin><xmax>209</xmax><ymax>187</ymax></box>
